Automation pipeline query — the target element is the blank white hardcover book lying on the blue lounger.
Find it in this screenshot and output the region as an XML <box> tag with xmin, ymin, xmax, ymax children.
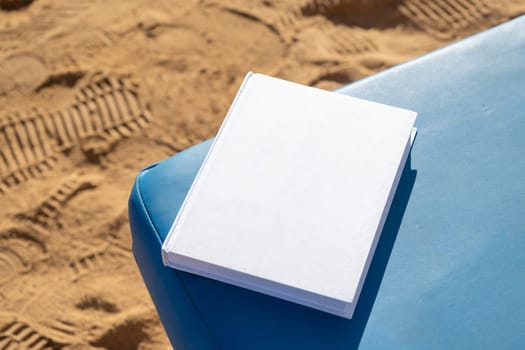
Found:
<box><xmin>162</xmin><ymin>73</ymin><xmax>416</xmax><ymax>318</ymax></box>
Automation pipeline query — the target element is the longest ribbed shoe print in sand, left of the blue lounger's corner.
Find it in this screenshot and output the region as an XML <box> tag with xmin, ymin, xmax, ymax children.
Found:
<box><xmin>0</xmin><ymin>76</ymin><xmax>151</xmax><ymax>193</ymax></box>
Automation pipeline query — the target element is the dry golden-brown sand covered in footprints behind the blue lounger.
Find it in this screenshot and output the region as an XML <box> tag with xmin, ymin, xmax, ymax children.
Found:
<box><xmin>0</xmin><ymin>0</ymin><xmax>525</xmax><ymax>350</ymax></box>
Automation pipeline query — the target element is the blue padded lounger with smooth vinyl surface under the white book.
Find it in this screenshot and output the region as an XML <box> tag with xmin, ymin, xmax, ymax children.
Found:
<box><xmin>130</xmin><ymin>17</ymin><xmax>525</xmax><ymax>350</ymax></box>
